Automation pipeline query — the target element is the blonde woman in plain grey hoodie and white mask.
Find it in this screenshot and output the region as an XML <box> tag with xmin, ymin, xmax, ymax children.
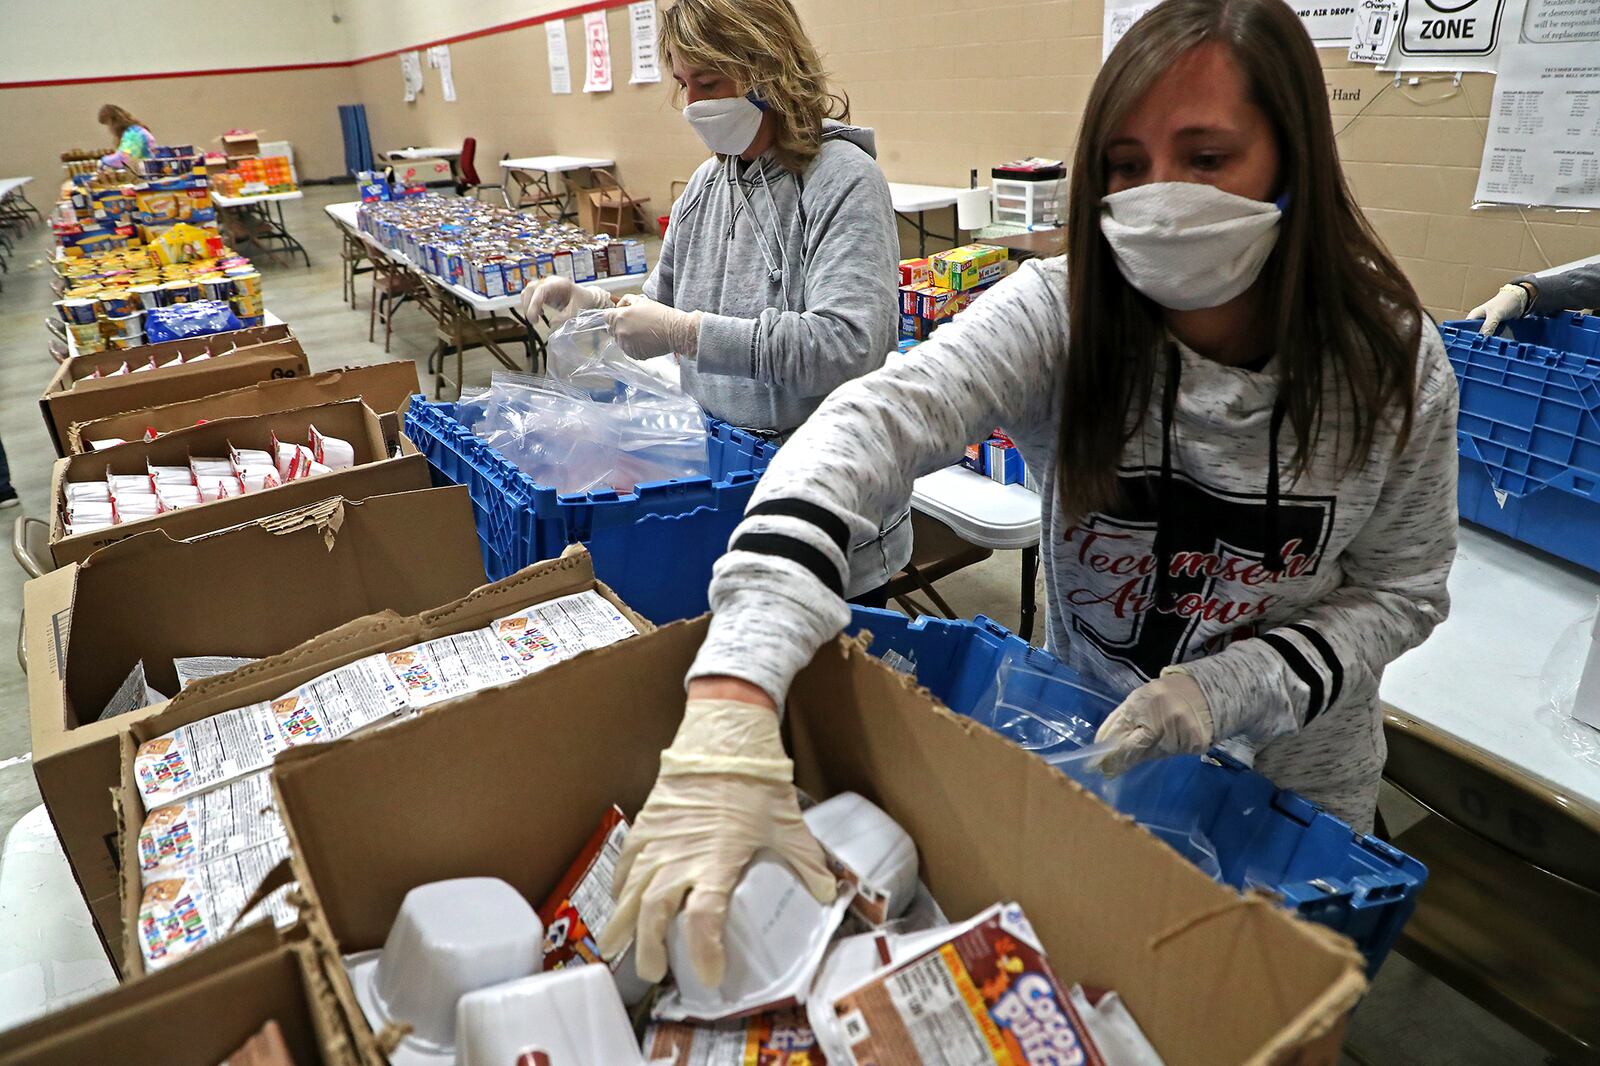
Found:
<box><xmin>523</xmin><ymin>0</ymin><xmax>908</xmax><ymax>605</ymax></box>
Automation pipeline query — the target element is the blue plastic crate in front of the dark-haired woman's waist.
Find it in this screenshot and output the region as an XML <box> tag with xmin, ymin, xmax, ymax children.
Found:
<box><xmin>850</xmin><ymin>607</ymin><xmax>1427</xmax><ymax>973</ymax></box>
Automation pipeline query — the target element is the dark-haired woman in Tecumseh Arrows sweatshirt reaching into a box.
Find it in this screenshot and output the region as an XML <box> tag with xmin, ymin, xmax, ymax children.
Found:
<box><xmin>606</xmin><ymin>0</ymin><xmax>1456</xmax><ymax>976</ymax></box>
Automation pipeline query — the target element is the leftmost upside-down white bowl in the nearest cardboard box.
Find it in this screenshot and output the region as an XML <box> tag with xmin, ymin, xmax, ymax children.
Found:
<box><xmin>344</xmin><ymin>877</ymin><xmax>544</xmax><ymax>1066</ymax></box>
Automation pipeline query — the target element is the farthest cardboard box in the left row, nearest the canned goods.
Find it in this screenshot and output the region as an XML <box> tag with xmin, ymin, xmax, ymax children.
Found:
<box><xmin>38</xmin><ymin>325</ymin><xmax>310</xmax><ymax>455</ymax></box>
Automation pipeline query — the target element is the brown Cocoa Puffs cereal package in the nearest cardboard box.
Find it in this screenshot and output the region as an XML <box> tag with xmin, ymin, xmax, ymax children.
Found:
<box><xmin>832</xmin><ymin>903</ymin><xmax>1104</xmax><ymax>1066</ymax></box>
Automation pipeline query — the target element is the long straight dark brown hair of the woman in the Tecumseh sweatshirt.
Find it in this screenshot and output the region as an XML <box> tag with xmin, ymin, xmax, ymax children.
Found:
<box><xmin>1059</xmin><ymin>0</ymin><xmax>1422</xmax><ymax>519</ymax></box>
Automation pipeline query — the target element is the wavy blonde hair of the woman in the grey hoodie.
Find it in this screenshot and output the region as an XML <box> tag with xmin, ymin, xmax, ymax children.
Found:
<box><xmin>661</xmin><ymin>0</ymin><xmax>850</xmax><ymax>173</ymax></box>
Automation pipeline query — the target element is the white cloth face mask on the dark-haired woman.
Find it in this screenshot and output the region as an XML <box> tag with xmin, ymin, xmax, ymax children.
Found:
<box><xmin>1101</xmin><ymin>181</ymin><xmax>1283</xmax><ymax>311</ymax></box>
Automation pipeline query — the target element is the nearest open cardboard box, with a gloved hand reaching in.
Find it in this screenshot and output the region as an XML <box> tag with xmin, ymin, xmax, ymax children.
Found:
<box><xmin>272</xmin><ymin>619</ymin><xmax>1366</xmax><ymax>1066</ymax></box>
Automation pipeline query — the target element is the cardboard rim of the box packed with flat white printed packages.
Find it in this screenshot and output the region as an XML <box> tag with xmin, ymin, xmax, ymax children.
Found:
<box><xmin>114</xmin><ymin>544</ymin><xmax>653</xmax><ymax>975</ymax></box>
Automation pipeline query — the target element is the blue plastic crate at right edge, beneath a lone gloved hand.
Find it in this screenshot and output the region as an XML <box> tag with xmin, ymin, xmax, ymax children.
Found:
<box><xmin>1440</xmin><ymin>314</ymin><xmax>1600</xmax><ymax>570</ymax></box>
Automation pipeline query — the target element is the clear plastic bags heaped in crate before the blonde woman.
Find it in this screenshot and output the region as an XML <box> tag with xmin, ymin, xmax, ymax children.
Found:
<box><xmin>461</xmin><ymin>312</ymin><xmax>710</xmax><ymax>493</ymax></box>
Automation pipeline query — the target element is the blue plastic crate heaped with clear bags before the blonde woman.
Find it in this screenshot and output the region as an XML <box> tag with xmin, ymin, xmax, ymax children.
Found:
<box><xmin>405</xmin><ymin>395</ymin><xmax>778</xmax><ymax>623</ymax></box>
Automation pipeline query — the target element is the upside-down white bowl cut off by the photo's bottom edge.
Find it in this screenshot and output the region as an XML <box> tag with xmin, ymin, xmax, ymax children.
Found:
<box><xmin>456</xmin><ymin>964</ymin><xmax>645</xmax><ymax>1066</ymax></box>
